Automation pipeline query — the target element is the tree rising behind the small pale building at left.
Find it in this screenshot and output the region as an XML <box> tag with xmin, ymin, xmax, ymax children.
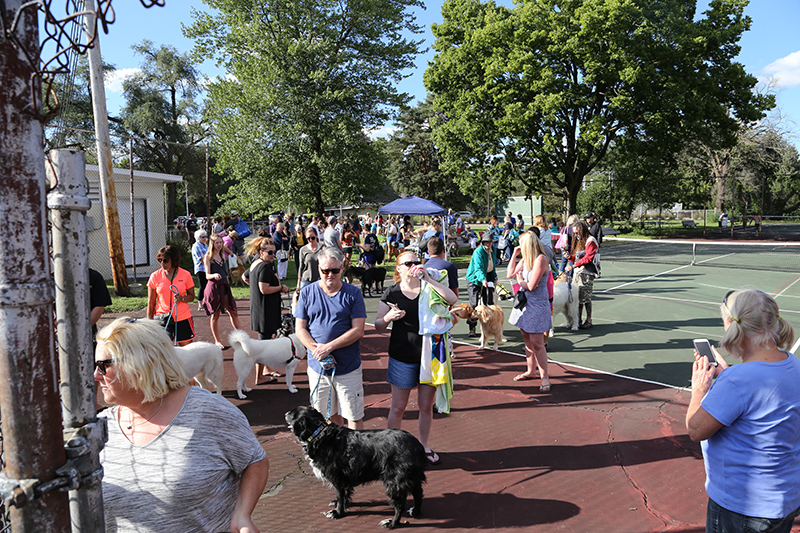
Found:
<box><xmin>120</xmin><ymin>40</ymin><xmax>210</xmax><ymax>220</ymax></box>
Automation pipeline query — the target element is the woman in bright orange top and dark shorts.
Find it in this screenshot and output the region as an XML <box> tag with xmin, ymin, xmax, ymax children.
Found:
<box><xmin>147</xmin><ymin>244</ymin><xmax>194</xmax><ymax>346</ymax></box>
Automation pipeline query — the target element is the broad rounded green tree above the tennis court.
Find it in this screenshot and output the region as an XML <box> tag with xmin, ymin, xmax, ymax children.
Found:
<box><xmin>425</xmin><ymin>0</ymin><xmax>773</xmax><ymax>216</ymax></box>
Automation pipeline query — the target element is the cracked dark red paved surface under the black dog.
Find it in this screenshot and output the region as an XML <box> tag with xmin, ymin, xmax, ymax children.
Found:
<box><xmin>104</xmin><ymin>301</ymin><xmax>800</xmax><ymax>532</ymax></box>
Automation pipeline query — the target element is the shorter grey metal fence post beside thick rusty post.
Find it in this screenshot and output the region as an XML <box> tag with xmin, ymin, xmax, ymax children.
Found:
<box><xmin>47</xmin><ymin>150</ymin><xmax>108</xmax><ymax>533</ymax></box>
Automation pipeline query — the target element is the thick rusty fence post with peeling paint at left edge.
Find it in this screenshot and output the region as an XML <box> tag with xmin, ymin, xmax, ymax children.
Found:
<box><xmin>0</xmin><ymin>0</ymin><xmax>70</xmax><ymax>532</ymax></box>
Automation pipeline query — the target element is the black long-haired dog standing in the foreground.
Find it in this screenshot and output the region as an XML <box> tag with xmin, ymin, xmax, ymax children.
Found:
<box><xmin>286</xmin><ymin>406</ymin><xmax>428</xmax><ymax>529</ymax></box>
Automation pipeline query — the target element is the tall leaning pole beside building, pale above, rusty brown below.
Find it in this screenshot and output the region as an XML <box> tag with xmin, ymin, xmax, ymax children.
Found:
<box><xmin>85</xmin><ymin>0</ymin><xmax>130</xmax><ymax>296</ymax></box>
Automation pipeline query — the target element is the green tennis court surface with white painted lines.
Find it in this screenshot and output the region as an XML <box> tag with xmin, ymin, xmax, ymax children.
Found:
<box><xmin>440</xmin><ymin>239</ymin><xmax>800</xmax><ymax>387</ymax></box>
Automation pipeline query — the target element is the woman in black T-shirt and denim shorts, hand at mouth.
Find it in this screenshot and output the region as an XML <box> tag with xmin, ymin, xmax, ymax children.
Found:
<box><xmin>375</xmin><ymin>252</ymin><xmax>458</xmax><ymax>464</ymax></box>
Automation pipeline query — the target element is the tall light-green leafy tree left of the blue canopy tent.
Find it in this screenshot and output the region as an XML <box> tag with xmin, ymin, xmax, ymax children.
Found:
<box><xmin>184</xmin><ymin>0</ymin><xmax>421</xmax><ymax>217</ymax></box>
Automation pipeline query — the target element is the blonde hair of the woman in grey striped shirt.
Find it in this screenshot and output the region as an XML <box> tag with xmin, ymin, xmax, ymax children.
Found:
<box><xmin>97</xmin><ymin>317</ymin><xmax>189</xmax><ymax>403</ymax></box>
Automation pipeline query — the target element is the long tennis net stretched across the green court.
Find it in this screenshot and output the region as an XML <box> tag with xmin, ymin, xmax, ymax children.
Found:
<box><xmin>600</xmin><ymin>239</ymin><xmax>800</xmax><ymax>272</ymax></box>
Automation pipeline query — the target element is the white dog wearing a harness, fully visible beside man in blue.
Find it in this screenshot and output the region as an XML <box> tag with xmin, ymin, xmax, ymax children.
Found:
<box><xmin>228</xmin><ymin>329</ymin><xmax>306</xmax><ymax>400</ymax></box>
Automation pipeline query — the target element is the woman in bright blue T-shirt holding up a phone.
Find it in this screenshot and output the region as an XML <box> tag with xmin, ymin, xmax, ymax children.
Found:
<box><xmin>686</xmin><ymin>290</ymin><xmax>800</xmax><ymax>533</ymax></box>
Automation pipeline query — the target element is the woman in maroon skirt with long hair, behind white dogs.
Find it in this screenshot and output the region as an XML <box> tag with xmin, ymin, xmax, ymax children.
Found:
<box><xmin>201</xmin><ymin>235</ymin><xmax>242</xmax><ymax>350</ymax></box>
